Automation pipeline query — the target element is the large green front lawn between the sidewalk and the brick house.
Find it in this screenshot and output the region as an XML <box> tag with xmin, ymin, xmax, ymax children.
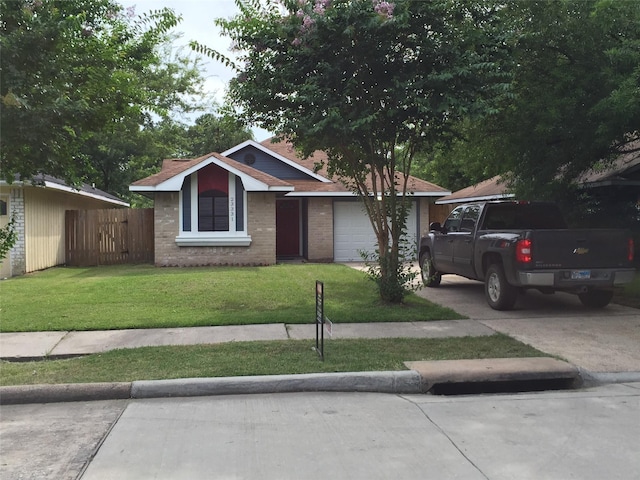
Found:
<box><xmin>0</xmin><ymin>264</ymin><xmax>464</xmax><ymax>332</ymax></box>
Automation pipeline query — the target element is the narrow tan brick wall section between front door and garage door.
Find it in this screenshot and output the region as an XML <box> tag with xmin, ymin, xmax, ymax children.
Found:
<box><xmin>307</xmin><ymin>197</ymin><xmax>333</xmax><ymax>262</ymax></box>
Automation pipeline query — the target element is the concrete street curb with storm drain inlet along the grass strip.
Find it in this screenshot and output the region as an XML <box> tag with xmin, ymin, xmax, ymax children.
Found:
<box><xmin>0</xmin><ymin>357</ymin><xmax>583</xmax><ymax>405</ymax></box>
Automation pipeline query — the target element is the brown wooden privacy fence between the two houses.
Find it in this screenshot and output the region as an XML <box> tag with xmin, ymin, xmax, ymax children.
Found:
<box><xmin>65</xmin><ymin>208</ymin><xmax>153</xmax><ymax>267</ymax></box>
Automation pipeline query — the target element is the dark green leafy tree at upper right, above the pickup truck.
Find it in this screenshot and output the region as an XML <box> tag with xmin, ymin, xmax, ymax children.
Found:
<box><xmin>428</xmin><ymin>0</ymin><xmax>640</xmax><ymax>200</ymax></box>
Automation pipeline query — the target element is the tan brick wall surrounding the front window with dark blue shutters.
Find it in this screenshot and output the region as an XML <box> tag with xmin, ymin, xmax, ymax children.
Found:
<box><xmin>154</xmin><ymin>192</ymin><xmax>276</xmax><ymax>267</ymax></box>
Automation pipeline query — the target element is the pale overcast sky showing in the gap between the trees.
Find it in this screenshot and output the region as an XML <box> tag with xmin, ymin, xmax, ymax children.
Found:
<box><xmin>119</xmin><ymin>0</ymin><xmax>271</xmax><ymax>141</ymax></box>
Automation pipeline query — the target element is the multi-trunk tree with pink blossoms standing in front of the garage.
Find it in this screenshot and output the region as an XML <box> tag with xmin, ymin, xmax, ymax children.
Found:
<box><xmin>205</xmin><ymin>0</ymin><xmax>506</xmax><ymax>302</ymax></box>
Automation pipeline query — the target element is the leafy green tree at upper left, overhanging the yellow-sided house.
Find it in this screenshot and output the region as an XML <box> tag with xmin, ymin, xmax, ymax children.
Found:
<box><xmin>0</xmin><ymin>0</ymin><xmax>188</xmax><ymax>189</ymax></box>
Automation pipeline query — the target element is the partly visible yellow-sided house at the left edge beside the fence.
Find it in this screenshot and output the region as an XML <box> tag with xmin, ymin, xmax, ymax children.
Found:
<box><xmin>0</xmin><ymin>175</ymin><xmax>129</xmax><ymax>278</ymax></box>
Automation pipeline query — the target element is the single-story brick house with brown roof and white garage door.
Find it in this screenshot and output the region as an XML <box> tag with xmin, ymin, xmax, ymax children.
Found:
<box><xmin>130</xmin><ymin>140</ymin><xmax>450</xmax><ymax>266</ymax></box>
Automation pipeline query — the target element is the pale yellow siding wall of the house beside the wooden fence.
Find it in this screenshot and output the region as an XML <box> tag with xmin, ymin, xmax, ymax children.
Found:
<box><xmin>24</xmin><ymin>187</ymin><xmax>119</xmax><ymax>272</ymax></box>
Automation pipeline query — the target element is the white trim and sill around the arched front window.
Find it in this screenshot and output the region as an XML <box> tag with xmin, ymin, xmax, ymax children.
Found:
<box><xmin>175</xmin><ymin>170</ymin><xmax>251</xmax><ymax>247</ymax></box>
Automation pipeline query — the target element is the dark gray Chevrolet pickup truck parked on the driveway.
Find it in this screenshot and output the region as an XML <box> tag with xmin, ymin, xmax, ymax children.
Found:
<box><xmin>420</xmin><ymin>201</ymin><xmax>635</xmax><ymax>310</ymax></box>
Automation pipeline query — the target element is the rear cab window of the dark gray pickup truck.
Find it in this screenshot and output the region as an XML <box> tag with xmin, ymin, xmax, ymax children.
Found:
<box><xmin>483</xmin><ymin>203</ymin><xmax>567</xmax><ymax>230</ymax></box>
